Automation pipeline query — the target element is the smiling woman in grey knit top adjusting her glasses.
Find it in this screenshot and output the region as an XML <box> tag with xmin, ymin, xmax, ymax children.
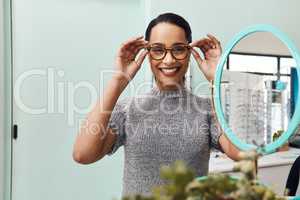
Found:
<box><xmin>73</xmin><ymin>13</ymin><xmax>238</xmax><ymax>195</ymax></box>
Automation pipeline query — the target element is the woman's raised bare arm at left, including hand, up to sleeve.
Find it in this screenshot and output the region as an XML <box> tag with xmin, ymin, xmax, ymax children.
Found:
<box><xmin>73</xmin><ymin>37</ymin><xmax>147</xmax><ymax>164</ymax></box>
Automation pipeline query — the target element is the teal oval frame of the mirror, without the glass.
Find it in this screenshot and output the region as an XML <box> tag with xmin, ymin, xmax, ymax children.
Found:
<box><xmin>213</xmin><ymin>24</ymin><xmax>300</xmax><ymax>155</ymax></box>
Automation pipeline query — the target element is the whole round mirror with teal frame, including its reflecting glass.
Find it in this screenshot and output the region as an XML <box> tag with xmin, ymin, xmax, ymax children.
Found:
<box><xmin>214</xmin><ymin>25</ymin><xmax>300</xmax><ymax>154</ymax></box>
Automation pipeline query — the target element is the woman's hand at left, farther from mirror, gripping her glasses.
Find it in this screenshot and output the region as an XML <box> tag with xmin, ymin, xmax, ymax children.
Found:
<box><xmin>116</xmin><ymin>36</ymin><xmax>148</xmax><ymax>82</ymax></box>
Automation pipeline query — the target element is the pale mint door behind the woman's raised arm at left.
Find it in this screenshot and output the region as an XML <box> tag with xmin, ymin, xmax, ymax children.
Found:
<box><xmin>12</xmin><ymin>0</ymin><xmax>146</xmax><ymax>200</ymax></box>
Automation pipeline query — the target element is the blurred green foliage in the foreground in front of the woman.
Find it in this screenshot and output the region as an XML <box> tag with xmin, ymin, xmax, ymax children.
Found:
<box><xmin>122</xmin><ymin>152</ymin><xmax>286</xmax><ymax>200</ymax></box>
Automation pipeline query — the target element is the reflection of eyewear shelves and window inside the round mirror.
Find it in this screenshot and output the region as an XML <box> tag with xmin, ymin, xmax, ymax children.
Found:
<box><xmin>221</xmin><ymin>32</ymin><xmax>296</xmax><ymax>146</ymax></box>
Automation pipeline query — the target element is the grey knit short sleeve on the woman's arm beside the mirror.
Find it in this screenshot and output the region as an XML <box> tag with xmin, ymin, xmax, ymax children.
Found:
<box><xmin>207</xmin><ymin>99</ymin><xmax>223</xmax><ymax>152</ymax></box>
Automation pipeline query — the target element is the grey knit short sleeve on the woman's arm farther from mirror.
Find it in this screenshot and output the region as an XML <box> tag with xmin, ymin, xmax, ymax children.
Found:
<box><xmin>108</xmin><ymin>99</ymin><xmax>127</xmax><ymax>155</ymax></box>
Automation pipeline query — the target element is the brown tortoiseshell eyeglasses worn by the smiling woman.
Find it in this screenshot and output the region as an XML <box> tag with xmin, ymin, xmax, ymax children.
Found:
<box><xmin>146</xmin><ymin>43</ymin><xmax>191</xmax><ymax>60</ymax></box>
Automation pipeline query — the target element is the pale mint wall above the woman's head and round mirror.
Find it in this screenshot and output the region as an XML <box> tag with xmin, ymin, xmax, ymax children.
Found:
<box><xmin>151</xmin><ymin>0</ymin><xmax>300</xmax><ymax>47</ymax></box>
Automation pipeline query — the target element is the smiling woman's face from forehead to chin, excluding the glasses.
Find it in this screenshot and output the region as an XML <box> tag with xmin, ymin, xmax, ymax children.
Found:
<box><xmin>149</xmin><ymin>23</ymin><xmax>190</xmax><ymax>90</ymax></box>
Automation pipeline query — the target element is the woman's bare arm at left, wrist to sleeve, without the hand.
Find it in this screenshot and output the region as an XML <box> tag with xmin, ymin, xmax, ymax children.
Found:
<box><xmin>73</xmin><ymin>77</ymin><xmax>128</xmax><ymax>164</ymax></box>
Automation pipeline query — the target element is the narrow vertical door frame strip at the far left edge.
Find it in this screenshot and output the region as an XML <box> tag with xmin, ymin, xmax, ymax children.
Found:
<box><xmin>1</xmin><ymin>0</ymin><xmax>13</xmax><ymax>200</ymax></box>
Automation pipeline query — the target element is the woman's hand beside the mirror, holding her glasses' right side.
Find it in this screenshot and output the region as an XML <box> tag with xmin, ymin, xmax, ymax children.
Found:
<box><xmin>190</xmin><ymin>34</ymin><xmax>222</xmax><ymax>81</ymax></box>
